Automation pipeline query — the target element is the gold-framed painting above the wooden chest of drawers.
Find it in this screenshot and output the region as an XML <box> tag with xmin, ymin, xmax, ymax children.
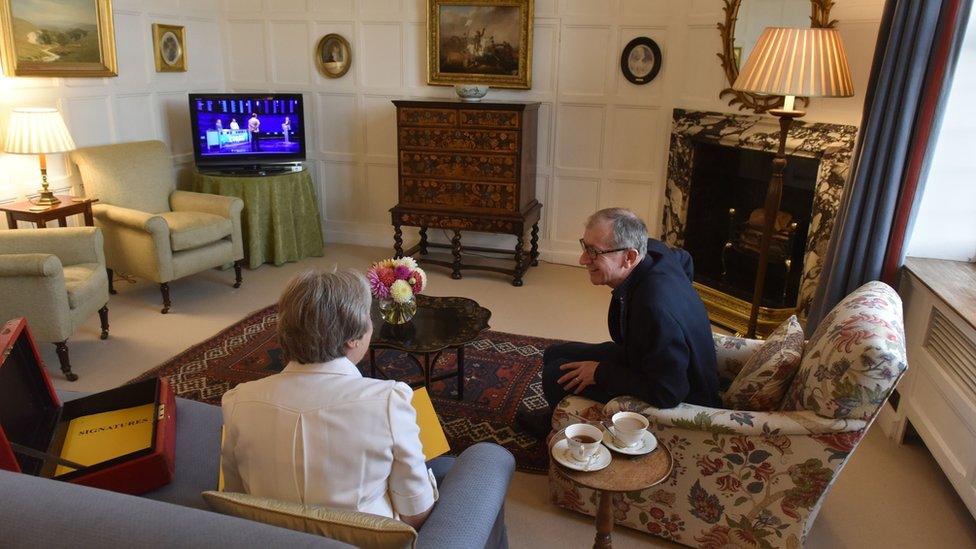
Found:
<box><xmin>427</xmin><ymin>0</ymin><xmax>534</xmax><ymax>90</ymax></box>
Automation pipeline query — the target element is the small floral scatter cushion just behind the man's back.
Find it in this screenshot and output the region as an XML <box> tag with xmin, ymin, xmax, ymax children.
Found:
<box><xmin>722</xmin><ymin>315</ymin><xmax>803</xmax><ymax>411</ymax></box>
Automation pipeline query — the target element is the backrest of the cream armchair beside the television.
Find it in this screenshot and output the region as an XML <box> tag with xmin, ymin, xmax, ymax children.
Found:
<box><xmin>71</xmin><ymin>141</ymin><xmax>176</xmax><ymax>213</ymax></box>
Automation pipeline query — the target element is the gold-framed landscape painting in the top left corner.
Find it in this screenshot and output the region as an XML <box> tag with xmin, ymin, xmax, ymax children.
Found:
<box><xmin>0</xmin><ymin>0</ymin><xmax>118</xmax><ymax>77</ymax></box>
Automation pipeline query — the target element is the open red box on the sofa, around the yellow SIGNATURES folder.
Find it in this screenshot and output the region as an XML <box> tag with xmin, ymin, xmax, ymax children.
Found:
<box><xmin>0</xmin><ymin>318</ymin><xmax>176</xmax><ymax>494</ymax></box>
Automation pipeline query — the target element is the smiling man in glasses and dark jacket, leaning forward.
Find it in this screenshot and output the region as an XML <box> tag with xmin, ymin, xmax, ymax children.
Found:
<box><xmin>519</xmin><ymin>208</ymin><xmax>720</xmax><ymax>438</ymax></box>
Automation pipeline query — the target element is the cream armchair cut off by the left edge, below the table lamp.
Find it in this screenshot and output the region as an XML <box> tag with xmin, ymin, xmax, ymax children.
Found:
<box><xmin>0</xmin><ymin>227</ymin><xmax>108</xmax><ymax>381</ymax></box>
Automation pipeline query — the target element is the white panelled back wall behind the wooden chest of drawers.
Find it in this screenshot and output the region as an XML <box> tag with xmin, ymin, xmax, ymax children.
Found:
<box><xmin>223</xmin><ymin>0</ymin><xmax>883</xmax><ymax>263</ymax></box>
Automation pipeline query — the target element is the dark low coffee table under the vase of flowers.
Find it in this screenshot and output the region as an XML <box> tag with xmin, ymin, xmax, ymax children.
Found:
<box><xmin>369</xmin><ymin>294</ymin><xmax>491</xmax><ymax>400</ymax></box>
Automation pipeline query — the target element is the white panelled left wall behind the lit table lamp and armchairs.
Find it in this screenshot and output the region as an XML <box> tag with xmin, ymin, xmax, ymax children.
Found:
<box><xmin>0</xmin><ymin>0</ymin><xmax>225</xmax><ymax>214</ymax></box>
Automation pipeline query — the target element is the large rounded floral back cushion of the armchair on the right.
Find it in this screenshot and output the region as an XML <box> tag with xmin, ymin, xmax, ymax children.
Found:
<box><xmin>781</xmin><ymin>282</ymin><xmax>908</xmax><ymax>420</ymax></box>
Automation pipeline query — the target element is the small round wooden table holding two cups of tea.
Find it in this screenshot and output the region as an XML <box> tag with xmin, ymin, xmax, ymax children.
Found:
<box><xmin>549</xmin><ymin>431</ymin><xmax>674</xmax><ymax>549</ymax></box>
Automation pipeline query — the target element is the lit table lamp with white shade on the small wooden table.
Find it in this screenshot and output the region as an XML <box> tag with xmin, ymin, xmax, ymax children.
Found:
<box><xmin>3</xmin><ymin>107</ymin><xmax>75</xmax><ymax>210</ymax></box>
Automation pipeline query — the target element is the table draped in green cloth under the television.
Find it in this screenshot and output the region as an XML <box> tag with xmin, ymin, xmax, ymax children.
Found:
<box><xmin>193</xmin><ymin>170</ymin><xmax>325</xmax><ymax>269</ymax></box>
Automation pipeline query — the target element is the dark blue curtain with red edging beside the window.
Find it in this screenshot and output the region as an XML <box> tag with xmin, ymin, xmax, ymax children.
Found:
<box><xmin>807</xmin><ymin>0</ymin><xmax>973</xmax><ymax>335</ymax></box>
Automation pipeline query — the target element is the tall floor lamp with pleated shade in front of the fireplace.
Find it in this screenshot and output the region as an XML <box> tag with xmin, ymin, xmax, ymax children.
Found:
<box><xmin>732</xmin><ymin>27</ymin><xmax>854</xmax><ymax>338</ymax></box>
